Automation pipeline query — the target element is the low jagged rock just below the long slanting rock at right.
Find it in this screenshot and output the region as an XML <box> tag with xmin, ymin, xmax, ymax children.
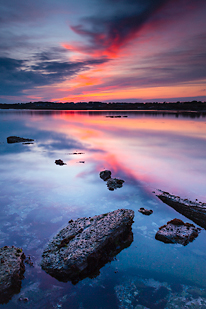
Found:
<box><xmin>155</xmin><ymin>218</ymin><xmax>201</xmax><ymax>246</ymax></box>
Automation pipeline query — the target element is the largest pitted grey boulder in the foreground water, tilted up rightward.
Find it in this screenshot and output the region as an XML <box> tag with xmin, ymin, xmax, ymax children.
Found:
<box><xmin>41</xmin><ymin>209</ymin><xmax>134</xmax><ymax>283</ymax></box>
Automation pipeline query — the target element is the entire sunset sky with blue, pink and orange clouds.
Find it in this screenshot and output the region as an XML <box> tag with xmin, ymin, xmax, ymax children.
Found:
<box><xmin>0</xmin><ymin>0</ymin><xmax>206</xmax><ymax>103</ymax></box>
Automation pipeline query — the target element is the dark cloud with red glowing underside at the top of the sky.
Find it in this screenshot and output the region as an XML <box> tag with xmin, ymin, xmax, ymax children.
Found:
<box><xmin>71</xmin><ymin>0</ymin><xmax>169</xmax><ymax>53</ymax></box>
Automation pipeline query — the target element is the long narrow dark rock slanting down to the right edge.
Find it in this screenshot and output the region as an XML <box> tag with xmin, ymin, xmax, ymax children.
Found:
<box><xmin>157</xmin><ymin>191</ymin><xmax>206</xmax><ymax>229</ymax></box>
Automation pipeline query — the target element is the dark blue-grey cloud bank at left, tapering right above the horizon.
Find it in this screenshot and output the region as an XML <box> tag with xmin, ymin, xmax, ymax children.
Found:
<box><xmin>0</xmin><ymin>52</ymin><xmax>105</xmax><ymax>95</ymax></box>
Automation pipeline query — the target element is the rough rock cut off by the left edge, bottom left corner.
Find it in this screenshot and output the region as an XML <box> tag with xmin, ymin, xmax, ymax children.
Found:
<box><xmin>0</xmin><ymin>246</ymin><xmax>25</xmax><ymax>304</ymax></box>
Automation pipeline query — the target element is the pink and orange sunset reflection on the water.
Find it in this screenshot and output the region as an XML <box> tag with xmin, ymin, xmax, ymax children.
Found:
<box><xmin>27</xmin><ymin>112</ymin><xmax>206</xmax><ymax>200</ymax></box>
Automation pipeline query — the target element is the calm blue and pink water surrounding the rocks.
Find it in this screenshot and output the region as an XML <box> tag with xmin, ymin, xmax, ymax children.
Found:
<box><xmin>0</xmin><ymin>110</ymin><xmax>206</xmax><ymax>309</ymax></box>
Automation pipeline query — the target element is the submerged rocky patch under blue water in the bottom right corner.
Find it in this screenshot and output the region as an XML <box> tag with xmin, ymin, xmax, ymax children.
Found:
<box><xmin>114</xmin><ymin>276</ymin><xmax>206</xmax><ymax>309</ymax></box>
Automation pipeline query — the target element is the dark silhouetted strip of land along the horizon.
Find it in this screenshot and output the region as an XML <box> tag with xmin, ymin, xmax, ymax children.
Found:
<box><xmin>0</xmin><ymin>101</ymin><xmax>206</xmax><ymax>112</ymax></box>
